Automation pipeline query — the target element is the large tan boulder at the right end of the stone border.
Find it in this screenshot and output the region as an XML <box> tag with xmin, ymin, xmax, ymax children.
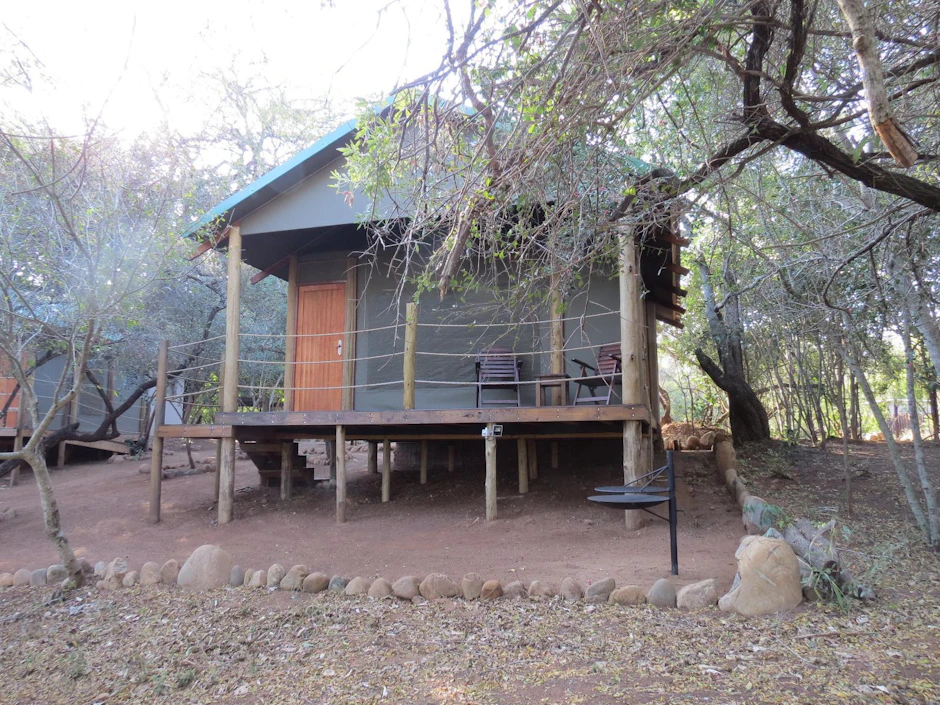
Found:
<box><xmin>718</xmin><ymin>536</ymin><xmax>803</xmax><ymax>617</ymax></box>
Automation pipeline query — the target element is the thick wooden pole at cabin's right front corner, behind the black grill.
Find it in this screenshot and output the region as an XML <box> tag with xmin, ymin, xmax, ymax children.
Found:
<box><xmin>620</xmin><ymin>229</ymin><xmax>646</xmax><ymax>529</ymax></box>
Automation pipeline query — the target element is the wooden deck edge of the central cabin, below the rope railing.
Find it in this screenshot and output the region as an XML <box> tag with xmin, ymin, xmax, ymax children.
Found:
<box><xmin>157</xmin><ymin>404</ymin><xmax>650</xmax><ymax>441</ymax></box>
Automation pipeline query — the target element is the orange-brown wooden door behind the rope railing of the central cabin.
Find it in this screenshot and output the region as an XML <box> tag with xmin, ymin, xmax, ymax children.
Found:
<box><xmin>294</xmin><ymin>282</ymin><xmax>346</xmax><ymax>411</ymax></box>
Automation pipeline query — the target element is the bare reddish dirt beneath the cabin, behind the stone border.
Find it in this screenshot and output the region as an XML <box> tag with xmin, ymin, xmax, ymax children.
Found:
<box><xmin>0</xmin><ymin>442</ymin><xmax>742</xmax><ymax>587</ymax></box>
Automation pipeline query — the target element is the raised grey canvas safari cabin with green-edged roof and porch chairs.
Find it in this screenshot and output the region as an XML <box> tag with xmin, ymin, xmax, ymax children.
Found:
<box><xmin>152</xmin><ymin>110</ymin><xmax>687</xmax><ymax>523</ymax></box>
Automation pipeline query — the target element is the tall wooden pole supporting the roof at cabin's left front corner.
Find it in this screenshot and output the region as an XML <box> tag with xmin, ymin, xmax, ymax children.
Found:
<box><xmin>219</xmin><ymin>225</ymin><xmax>242</xmax><ymax>525</ymax></box>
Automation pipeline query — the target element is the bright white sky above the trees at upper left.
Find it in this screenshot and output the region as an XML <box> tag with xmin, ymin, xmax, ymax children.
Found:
<box><xmin>0</xmin><ymin>0</ymin><xmax>452</xmax><ymax>135</ymax></box>
